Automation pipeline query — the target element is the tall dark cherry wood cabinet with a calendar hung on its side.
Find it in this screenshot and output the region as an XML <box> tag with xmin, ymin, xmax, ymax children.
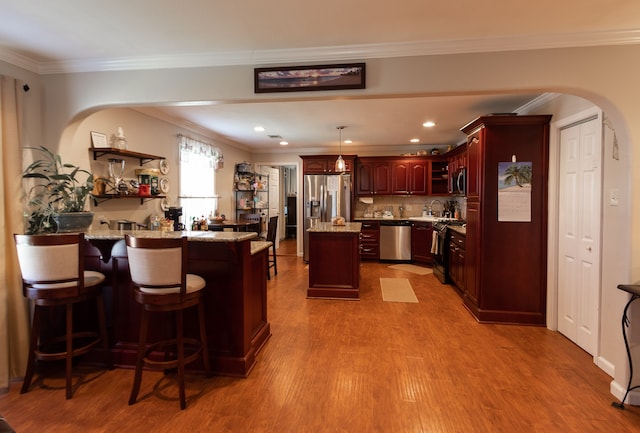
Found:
<box><xmin>462</xmin><ymin>115</ymin><xmax>551</xmax><ymax>325</ymax></box>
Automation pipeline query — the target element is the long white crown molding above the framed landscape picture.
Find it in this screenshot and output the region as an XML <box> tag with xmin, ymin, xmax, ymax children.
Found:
<box><xmin>0</xmin><ymin>30</ymin><xmax>640</xmax><ymax>75</ymax></box>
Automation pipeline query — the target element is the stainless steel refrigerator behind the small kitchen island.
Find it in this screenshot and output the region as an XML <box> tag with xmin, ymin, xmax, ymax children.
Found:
<box><xmin>303</xmin><ymin>174</ymin><xmax>352</xmax><ymax>262</ymax></box>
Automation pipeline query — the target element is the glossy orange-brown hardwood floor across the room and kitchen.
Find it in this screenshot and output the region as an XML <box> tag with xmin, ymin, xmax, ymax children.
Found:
<box><xmin>0</xmin><ymin>240</ymin><xmax>640</xmax><ymax>433</ymax></box>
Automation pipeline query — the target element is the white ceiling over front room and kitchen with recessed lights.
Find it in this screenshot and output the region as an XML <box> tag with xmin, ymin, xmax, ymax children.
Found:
<box><xmin>0</xmin><ymin>0</ymin><xmax>640</xmax><ymax>153</ymax></box>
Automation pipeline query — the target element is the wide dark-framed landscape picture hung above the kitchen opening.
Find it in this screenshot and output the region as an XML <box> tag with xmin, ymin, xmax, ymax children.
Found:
<box><xmin>254</xmin><ymin>63</ymin><xmax>366</xmax><ymax>93</ymax></box>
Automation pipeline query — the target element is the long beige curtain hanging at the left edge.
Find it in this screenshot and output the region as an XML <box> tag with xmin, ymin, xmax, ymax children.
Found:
<box><xmin>0</xmin><ymin>75</ymin><xmax>29</xmax><ymax>393</ymax></box>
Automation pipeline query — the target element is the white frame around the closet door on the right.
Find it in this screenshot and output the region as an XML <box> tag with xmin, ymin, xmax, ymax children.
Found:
<box><xmin>547</xmin><ymin>106</ymin><xmax>604</xmax><ymax>348</ymax></box>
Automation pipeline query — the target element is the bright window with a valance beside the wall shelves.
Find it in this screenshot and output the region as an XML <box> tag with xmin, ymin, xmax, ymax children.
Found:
<box><xmin>178</xmin><ymin>135</ymin><xmax>223</xmax><ymax>229</ymax></box>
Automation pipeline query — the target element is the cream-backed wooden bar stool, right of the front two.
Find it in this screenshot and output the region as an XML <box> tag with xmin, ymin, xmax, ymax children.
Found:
<box><xmin>125</xmin><ymin>235</ymin><xmax>211</xmax><ymax>409</ymax></box>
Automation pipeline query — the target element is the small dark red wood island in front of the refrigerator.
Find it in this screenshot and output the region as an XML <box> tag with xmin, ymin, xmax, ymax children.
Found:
<box><xmin>307</xmin><ymin>222</ymin><xmax>362</xmax><ymax>299</ymax></box>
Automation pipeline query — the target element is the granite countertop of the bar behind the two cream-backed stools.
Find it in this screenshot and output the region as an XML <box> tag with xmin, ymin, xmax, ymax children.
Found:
<box><xmin>84</xmin><ymin>230</ymin><xmax>258</xmax><ymax>241</ymax></box>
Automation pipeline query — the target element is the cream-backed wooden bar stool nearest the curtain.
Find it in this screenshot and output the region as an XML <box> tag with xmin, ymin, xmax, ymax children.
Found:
<box><xmin>14</xmin><ymin>233</ymin><xmax>111</xmax><ymax>400</ymax></box>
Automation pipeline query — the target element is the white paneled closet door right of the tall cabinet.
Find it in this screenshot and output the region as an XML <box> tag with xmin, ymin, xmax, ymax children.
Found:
<box><xmin>558</xmin><ymin>118</ymin><xmax>602</xmax><ymax>355</ymax></box>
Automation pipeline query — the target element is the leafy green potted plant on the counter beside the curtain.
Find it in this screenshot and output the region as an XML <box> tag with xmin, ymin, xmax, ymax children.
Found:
<box><xmin>22</xmin><ymin>146</ymin><xmax>94</xmax><ymax>234</ymax></box>
